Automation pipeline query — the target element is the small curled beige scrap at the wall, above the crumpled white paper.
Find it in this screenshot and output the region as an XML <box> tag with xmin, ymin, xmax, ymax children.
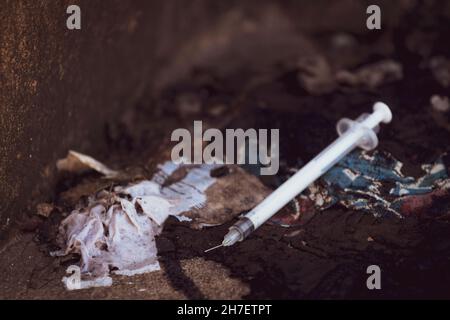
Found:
<box><xmin>56</xmin><ymin>150</ymin><xmax>119</xmax><ymax>178</ymax></box>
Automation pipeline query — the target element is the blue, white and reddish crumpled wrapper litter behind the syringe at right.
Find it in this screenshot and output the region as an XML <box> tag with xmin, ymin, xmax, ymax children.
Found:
<box><xmin>280</xmin><ymin>151</ymin><xmax>450</xmax><ymax>222</ymax></box>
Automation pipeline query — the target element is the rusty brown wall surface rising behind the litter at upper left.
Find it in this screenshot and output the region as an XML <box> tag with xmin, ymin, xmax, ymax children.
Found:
<box><xmin>0</xmin><ymin>0</ymin><xmax>406</xmax><ymax>225</ymax></box>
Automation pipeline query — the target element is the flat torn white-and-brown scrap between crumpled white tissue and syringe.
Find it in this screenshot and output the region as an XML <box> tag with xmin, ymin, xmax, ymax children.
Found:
<box><xmin>115</xmin><ymin>161</ymin><xmax>270</xmax><ymax>229</ymax></box>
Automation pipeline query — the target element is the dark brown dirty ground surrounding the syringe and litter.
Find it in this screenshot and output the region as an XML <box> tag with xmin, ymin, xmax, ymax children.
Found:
<box><xmin>0</xmin><ymin>2</ymin><xmax>450</xmax><ymax>299</ymax></box>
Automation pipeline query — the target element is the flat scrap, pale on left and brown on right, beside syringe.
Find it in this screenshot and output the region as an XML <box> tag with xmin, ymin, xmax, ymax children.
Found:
<box><xmin>135</xmin><ymin>161</ymin><xmax>270</xmax><ymax>229</ymax></box>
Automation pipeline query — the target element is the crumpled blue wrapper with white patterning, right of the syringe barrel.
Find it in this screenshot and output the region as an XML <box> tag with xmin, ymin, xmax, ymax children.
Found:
<box><xmin>322</xmin><ymin>151</ymin><xmax>450</xmax><ymax>216</ymax></box>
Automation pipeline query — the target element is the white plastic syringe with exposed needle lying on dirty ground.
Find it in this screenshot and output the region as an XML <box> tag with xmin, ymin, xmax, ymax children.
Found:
<box><xmin>206</xmin><ymin>102</ymin><xmax>392</xmax><ymax>251</ymax></box>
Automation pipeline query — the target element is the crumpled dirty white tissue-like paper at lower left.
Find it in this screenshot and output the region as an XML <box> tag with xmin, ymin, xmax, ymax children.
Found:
<box><xmin>53</xmin><ymin>195</ymin><xmax>160</xmax><ymax>277</ymax></box>
